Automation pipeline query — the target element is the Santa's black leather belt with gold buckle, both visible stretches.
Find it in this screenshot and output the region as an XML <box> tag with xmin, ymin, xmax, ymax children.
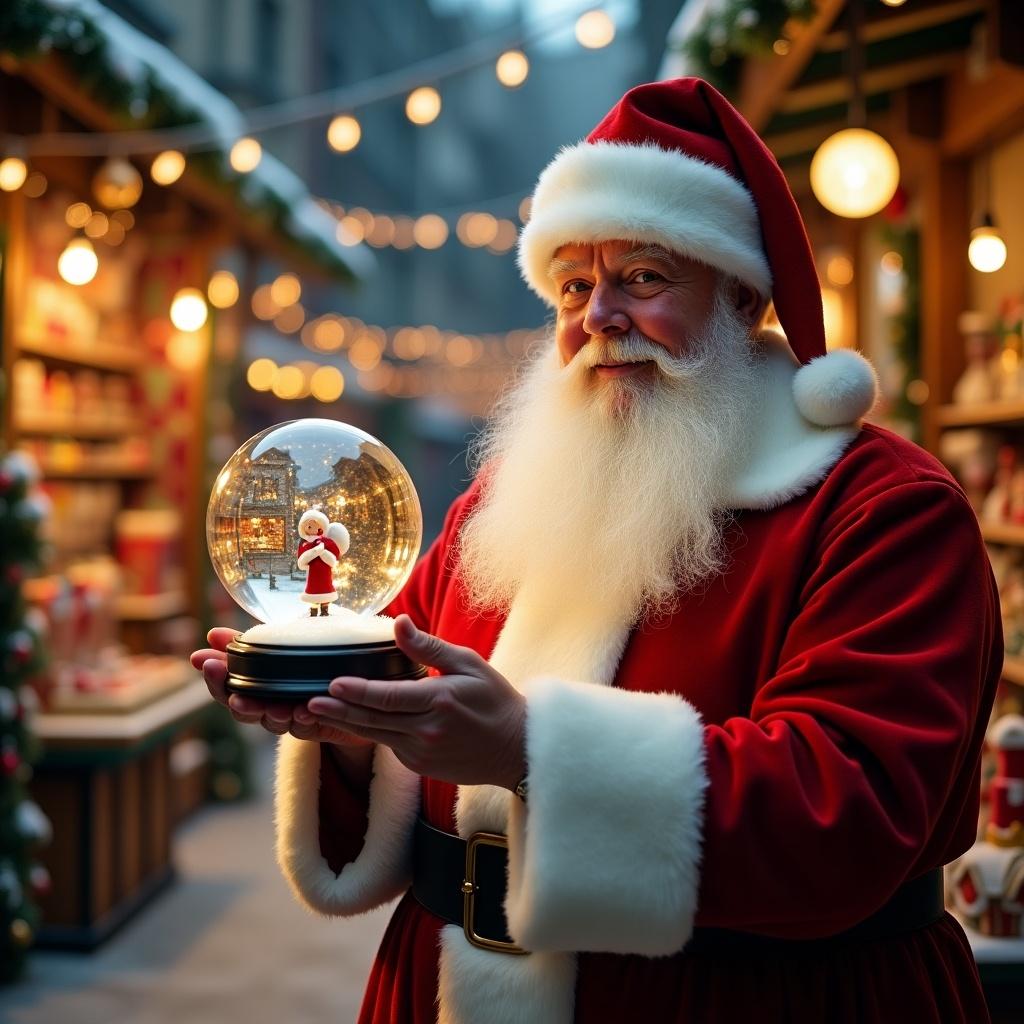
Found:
<box><xmin>413</xmin><ymin>817</ymin><xmax>945</xmax><ymax>953</ymax></box>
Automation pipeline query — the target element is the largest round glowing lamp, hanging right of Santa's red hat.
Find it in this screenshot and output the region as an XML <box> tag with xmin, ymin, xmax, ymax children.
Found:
<box><xmin>811</xmin><ymin>128</ymin><xmax>899</xmax><ymax>217</ymax></box>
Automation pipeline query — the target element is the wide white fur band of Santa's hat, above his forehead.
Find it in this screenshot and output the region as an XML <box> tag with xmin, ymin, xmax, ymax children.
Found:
<box><xmin>519</xmin><ymin>142</ymin><xmax>771</xmax><ymax>305</ymax></box>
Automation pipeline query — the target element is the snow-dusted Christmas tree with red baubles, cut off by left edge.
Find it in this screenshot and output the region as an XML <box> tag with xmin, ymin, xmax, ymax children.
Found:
<box><xmin>0</xmin><ymin>452</ymin><xmax>50</xmax><ymax>983</ymax></box>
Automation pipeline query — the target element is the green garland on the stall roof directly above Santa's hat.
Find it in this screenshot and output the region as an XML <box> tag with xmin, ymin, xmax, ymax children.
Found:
<box><xmin>672</xmin><ymin>0</ymin><xmax>817</xmax><ymax>95</ymax></box>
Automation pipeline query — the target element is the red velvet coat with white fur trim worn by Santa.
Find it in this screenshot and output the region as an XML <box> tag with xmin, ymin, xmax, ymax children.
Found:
<box><xmin>279</xmin><ymin>346</ymin><xmax>1001</xmax><ymax>1024</ymax></box>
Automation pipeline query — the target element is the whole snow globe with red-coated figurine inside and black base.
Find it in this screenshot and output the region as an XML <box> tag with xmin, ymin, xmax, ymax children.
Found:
<box><xmin>206</xmin><ymin>419</ymin><xmax>426</xmax><ymax>701</ymax></box>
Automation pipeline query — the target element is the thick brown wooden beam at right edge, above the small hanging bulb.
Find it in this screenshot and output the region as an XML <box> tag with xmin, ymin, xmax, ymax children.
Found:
<box><xmin>942</xmin><ymin>54</ymin><xmax>1024</xmax><ymax>157</ymax></box>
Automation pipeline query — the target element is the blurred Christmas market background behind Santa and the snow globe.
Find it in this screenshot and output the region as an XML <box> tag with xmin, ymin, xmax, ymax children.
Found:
<box><xmin>0</xmin><ymin>0</ymin><xmax>1024</xmax><ymax>1022</ymax></box>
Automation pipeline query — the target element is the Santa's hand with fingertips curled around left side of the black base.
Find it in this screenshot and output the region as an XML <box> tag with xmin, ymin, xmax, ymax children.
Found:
<box><xmin>189</xmin><ymin>627</ymin><xmax>369</xmax><ymax>746</ymax></box>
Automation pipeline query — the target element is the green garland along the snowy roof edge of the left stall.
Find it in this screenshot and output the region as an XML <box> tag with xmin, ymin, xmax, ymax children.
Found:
<box><xmin>0</xmin><ymin>0</ymin><xmax>354</xmax><ymax>282</ymax></box>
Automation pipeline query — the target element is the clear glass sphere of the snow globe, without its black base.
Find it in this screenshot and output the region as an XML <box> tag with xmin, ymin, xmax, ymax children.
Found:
<box><xmin>206</xmin><ymin>419</ymin><xmax>423</xmax><ymax>630</ymax></box>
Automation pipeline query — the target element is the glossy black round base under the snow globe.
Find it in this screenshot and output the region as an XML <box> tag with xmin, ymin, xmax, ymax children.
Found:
<box><xmin>227</xmin><ymin>640</ymin><xmax>427</xmax><ymax>701</ymax></box>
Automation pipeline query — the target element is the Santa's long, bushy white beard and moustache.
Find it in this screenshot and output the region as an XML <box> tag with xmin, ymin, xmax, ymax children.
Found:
<box><xmin>460</xmin><ymin>285</ymin><xmax>764</xmax><ymax>623</ymax></box>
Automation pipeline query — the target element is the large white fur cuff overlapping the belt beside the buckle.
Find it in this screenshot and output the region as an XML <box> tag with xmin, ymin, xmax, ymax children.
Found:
<box><xmin>505</xmin><ymin>679</ymin><xmax>708</xmax><ymax>955</ymax></box>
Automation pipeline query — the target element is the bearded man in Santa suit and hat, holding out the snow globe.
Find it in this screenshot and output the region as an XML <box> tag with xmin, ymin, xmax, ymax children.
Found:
<box><xmin>194</xmin><ymin>79</ymin><xmax>1001</xmax><ymax>1024</ymax></box>
